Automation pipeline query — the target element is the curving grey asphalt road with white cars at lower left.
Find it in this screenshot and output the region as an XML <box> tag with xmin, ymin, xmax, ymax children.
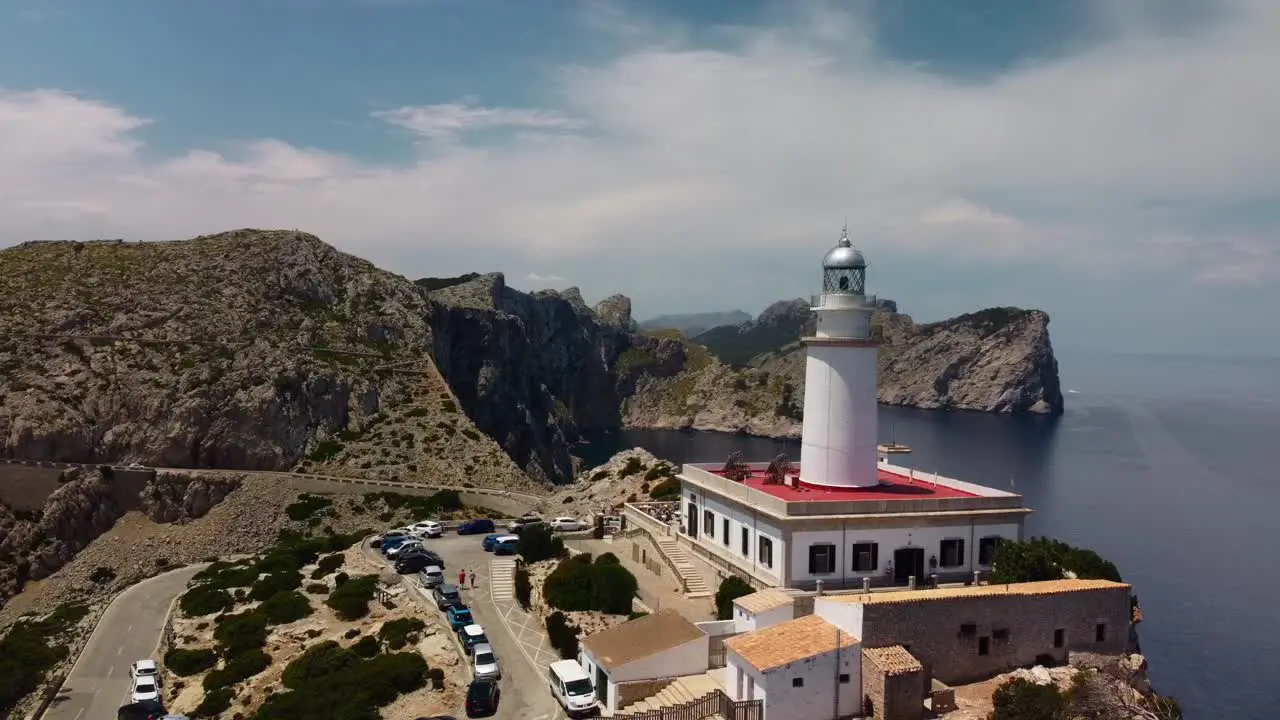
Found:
<box><xmin>45</xmin><ymin>565</ymin><xmax>205</xmax><ymax>720</ymax></box>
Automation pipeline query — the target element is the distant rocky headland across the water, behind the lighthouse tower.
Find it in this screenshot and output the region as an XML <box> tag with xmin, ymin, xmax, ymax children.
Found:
<box><xmin>623</xmin><ymin>302</ymin><xmax>1062</xmax><ymax>437</ymax></box>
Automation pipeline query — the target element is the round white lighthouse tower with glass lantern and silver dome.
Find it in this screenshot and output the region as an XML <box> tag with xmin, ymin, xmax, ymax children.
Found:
<box><xmin>800</xmin><ymin>225</ymin><xmax>879</xmax><ymax>487</ymax></box>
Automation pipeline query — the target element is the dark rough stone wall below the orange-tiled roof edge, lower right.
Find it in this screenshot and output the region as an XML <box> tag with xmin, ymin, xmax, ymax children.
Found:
<box><xmin>863</xmin><ymin>585</ymin><xmax>1129</xmax><ymax>685</ymax></box>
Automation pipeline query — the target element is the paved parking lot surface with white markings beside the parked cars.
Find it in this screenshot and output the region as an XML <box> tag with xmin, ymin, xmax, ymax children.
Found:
<box><xmin>365</xmin><ymin>530</ymin><xmax>564</xmax><ymax>720</ymax></box>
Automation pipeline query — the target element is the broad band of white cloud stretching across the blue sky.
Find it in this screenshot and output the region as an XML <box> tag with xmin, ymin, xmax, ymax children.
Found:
<box><xmin>0</xmin><ymin>0</ymin><xmax>1280</xmax><ymax>299</ymax></box>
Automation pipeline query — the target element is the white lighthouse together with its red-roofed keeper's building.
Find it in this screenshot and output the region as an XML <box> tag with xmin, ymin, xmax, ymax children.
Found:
<box><xmin>680</xmin><ymin>228</ymin><xmax>1030</xmax><ymax>589</ymax></box>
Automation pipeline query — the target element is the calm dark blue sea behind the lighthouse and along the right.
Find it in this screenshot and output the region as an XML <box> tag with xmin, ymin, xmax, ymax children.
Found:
<box><xmin>579</xmin><ymin>352</ymin><xmax>1280</xmax><ymax>720</ymax></box>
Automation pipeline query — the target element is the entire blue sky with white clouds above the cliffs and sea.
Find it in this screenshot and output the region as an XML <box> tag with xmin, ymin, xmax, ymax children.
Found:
<box><xmin>0</xmin><ymin>0</ymin><xmax>1280</xmax><ymax>355</ymax></box>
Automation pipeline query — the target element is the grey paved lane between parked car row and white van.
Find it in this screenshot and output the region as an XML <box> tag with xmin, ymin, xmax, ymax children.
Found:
<box><xmin>365</xmin><ymin>534</ymin><xmax>564</xmax><ymax>720</ymax></box>
